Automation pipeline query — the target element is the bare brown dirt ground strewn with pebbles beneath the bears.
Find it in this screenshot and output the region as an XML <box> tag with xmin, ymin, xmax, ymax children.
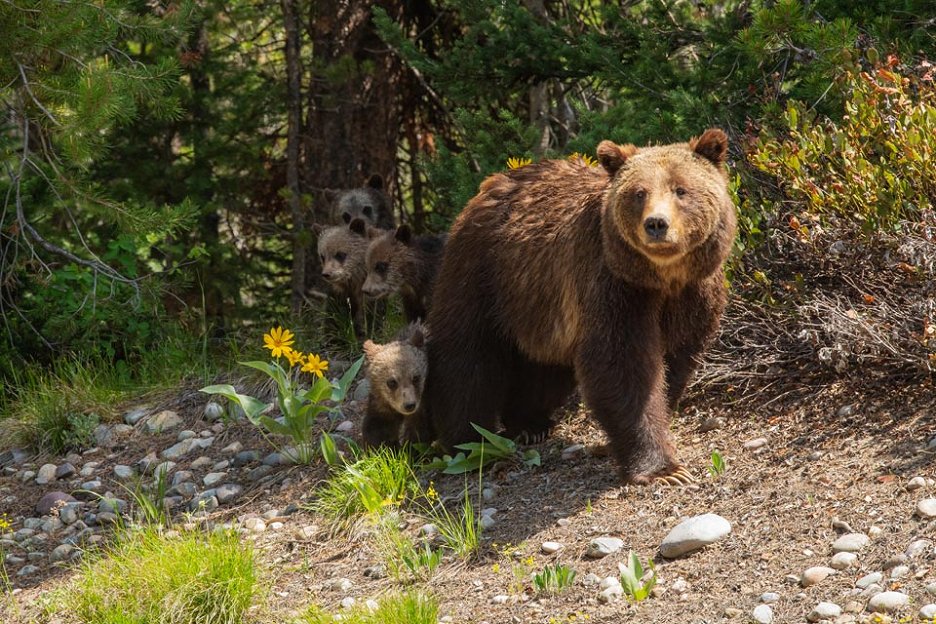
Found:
<box><xmin>0</xmin><ymin>372</ymin><xmax>936</xmax><ymax>624</ymax></box>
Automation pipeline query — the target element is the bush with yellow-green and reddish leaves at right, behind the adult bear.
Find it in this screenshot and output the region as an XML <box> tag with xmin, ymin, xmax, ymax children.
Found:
<box><xmin>748</xmin><ymin>56</ymin><xmax>936</xmax><ymax>230</ymax></box>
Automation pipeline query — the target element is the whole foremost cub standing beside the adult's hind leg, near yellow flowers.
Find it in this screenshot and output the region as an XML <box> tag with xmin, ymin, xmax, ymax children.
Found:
<box><xmin>361</xmin><ymin>323</ymin><xmax>427</xmax><ymax>446</ymax></box>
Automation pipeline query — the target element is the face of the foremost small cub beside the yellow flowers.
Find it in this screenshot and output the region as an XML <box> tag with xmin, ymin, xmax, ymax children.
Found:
<box><xmin>364</xmin><ymin>340</ymin><xmax>427</xmax><ymax>416</ymax></box>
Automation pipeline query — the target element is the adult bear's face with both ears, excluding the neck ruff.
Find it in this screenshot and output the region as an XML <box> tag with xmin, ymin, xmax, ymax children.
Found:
<box><xmin>598</xmin><ymin>130</ymin><xmax>733</xmax><ymax>266</ymax></box>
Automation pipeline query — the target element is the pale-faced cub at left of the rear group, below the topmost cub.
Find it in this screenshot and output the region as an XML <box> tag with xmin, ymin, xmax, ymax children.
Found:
<box><xmin>313</xmin><ymin>219</ymin><xmax>382</xmax><ymax>333</ymax></box>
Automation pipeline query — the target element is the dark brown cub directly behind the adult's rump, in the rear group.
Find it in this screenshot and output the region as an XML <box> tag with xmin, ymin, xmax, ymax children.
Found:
<box><xmin>363</xmin><ymin>225</ymin><xmax>446</xmax><ymax>322</ymax></box>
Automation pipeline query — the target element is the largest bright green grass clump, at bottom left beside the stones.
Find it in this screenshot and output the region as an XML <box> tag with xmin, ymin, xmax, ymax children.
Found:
<box><xmin>54</xmin><ymin>529</ymin><xmax>259</xmax><ymax>624</ymax></box>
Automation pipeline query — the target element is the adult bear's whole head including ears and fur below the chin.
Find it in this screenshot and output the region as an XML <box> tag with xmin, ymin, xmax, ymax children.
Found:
<box><xmin>597</xmin><ymin>129</ymin><xmax>735</xmax><ymax>282</ymax></box>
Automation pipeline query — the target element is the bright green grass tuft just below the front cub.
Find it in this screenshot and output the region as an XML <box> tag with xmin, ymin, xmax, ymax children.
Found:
<box><xmin>310</xmin><ymin>447</ymin><xmax>419</xmax><ymax>528</ymax></box>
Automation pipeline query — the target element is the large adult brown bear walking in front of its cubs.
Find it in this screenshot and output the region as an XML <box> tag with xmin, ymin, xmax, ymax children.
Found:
<box><xmin>426</xmin><ymin>129</ymin><xmax>735</xmax><ymax>484</ymax></box>
